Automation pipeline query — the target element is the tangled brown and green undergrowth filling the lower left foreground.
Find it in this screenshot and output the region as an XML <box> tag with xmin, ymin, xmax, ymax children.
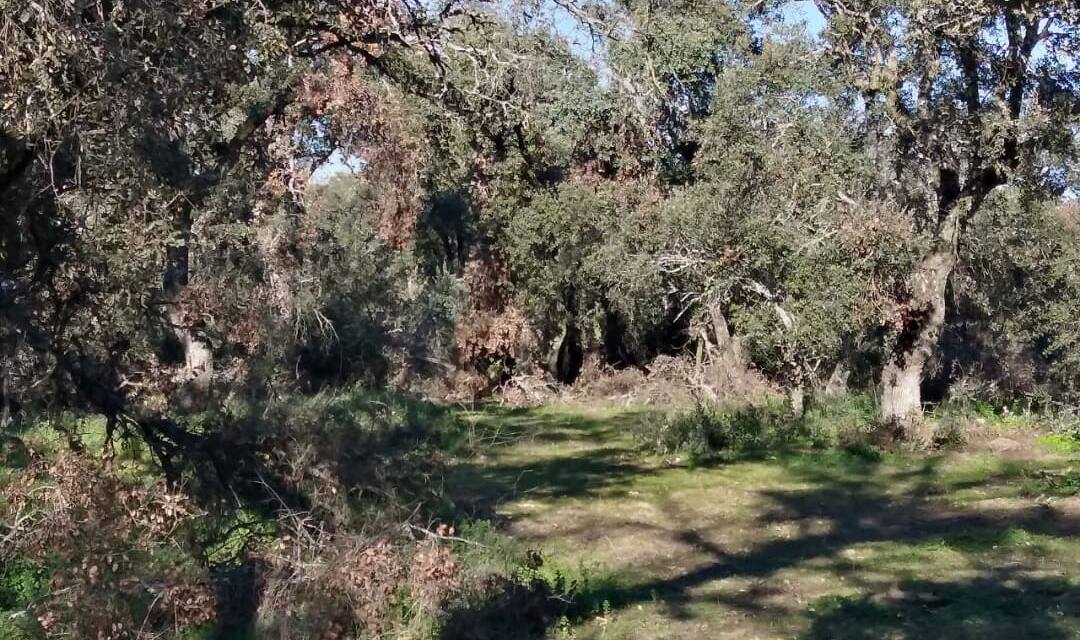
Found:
<box><xmin>0</xmin><ymin>389</ymin><xmax>544</xmax><ymax>640</ymax></box>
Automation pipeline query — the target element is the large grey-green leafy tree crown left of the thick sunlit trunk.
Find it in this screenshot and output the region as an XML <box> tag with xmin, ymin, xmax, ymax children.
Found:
<box><xmin>643</xmin><ymin>33</ymin><xmax>914</xmax><ymax>387</ymax></box>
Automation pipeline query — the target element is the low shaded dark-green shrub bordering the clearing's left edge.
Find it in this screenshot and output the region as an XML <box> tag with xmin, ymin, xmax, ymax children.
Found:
<box><xmin>182</xmin><ymin>386</ymin><xmax>465</xmax><ymax>527</ymax></box>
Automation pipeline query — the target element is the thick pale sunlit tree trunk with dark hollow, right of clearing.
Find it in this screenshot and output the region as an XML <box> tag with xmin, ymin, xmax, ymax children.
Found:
<box><xmin>881</xmin><ymin>205</ymin><xmax>961</xmax><ymax>425</ymax></box>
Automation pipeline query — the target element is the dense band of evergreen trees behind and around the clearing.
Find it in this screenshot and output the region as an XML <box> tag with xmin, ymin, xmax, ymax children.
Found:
<box><xmin>0</xmin><ymin>0</ymin><xmax>1080</xmax><ymax>448</ymax></box>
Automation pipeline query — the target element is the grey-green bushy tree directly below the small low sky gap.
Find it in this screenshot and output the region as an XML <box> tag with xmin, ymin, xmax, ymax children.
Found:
<box><xmin>291</xmin><ymin>177</ymin><xmax>460</xmax><ymax>389</ymax></box>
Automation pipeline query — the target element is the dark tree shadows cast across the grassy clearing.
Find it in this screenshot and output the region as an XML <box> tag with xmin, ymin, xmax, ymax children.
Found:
<box><xmin>446</xmin><ymin>403</ymin><xmax>1080</xmax><ymax>640</ymax></box>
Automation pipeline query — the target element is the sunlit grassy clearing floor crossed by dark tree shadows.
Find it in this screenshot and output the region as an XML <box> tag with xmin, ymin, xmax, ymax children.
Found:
<box><xmin>447</xmin><ymin>406</ymin><xmax>1080</xmax><ymax>640</ymax></box>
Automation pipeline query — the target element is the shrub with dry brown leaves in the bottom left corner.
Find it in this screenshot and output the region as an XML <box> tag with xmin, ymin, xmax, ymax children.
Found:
<box><xmin>0</xmin><ymin>453</ymin><xmax>214</xmax><ymax>638</ymax></box>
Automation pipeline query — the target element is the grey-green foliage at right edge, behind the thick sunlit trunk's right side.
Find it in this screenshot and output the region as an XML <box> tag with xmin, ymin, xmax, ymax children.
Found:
<box><xmin>944</xmin><ymin>192</ymin><xmax>1080</xmax><ymax>406</ymax></box>
